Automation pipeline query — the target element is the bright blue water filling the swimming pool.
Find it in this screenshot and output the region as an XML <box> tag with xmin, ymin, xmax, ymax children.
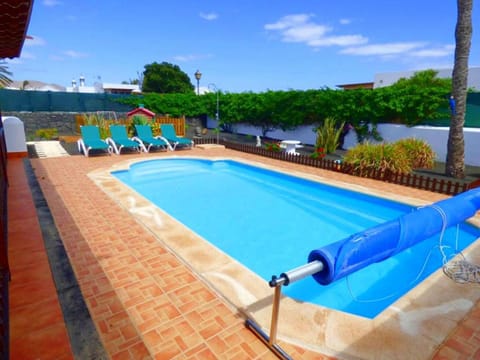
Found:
<box><xmin>112</xmin><ymin>159</ymin><xmax>480</xmax><ymax>318</ymax></box>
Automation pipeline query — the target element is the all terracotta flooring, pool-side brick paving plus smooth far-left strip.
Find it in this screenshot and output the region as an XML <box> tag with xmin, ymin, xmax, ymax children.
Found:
<box><xmin>8</xmin><ymin>149</ymin><xmax>480</xmax><ymax>359</ymax></box>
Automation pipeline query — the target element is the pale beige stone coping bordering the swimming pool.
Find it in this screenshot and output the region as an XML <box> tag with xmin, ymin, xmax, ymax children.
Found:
<box><xmin>88</xmin><ymin>155</ymin><xmax>480</xmax><ymax>359</ymax></box>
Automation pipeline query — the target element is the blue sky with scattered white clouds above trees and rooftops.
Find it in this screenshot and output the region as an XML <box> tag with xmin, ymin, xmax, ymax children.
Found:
<box><xmin>4</xmin><ymin>0</ymin><xmax>480</xmax><ymax>92</ymax></box>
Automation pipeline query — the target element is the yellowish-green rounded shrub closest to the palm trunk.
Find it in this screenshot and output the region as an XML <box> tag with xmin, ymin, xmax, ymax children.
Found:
<box><xmin>395</xmin><ymin>138</ymin><xmax>436</xmax><ymax>169</ymax></box>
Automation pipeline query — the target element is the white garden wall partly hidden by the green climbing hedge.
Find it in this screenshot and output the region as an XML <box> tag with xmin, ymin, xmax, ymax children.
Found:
<box><xmin>207</xmin><ymin>118</ymin><xmax>480</xmax><ymax>166</ymax></box>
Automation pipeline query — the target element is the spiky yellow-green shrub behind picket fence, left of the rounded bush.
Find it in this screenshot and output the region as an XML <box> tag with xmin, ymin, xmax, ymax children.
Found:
<box><xmin>343</xmin><ymin>142</ymin><xmax>412</xmax><ymax>176</ymax></box>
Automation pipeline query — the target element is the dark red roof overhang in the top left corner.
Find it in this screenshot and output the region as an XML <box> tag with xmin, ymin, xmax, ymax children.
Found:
<box><xmin>0</xmin><ymin>0</ymin><xmax>33</xmax><ymax>59</ymax></box>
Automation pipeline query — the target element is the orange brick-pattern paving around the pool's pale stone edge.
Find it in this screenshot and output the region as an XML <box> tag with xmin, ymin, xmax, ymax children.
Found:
<box><xmin>25</xmin><ymin>149</ymin><xmax>480</xmax><ymax>359</ymax></box>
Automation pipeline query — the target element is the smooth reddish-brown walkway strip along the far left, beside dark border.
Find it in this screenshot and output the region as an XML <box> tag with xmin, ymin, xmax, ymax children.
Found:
<box><xmin>8</xmin><ymin>158</ymin><xmax>74</xmax><ymax>360</ymax></box>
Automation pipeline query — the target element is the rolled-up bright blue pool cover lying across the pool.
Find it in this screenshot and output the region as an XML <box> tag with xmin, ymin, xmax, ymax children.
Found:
<box><xmin>308</xmin><ymin>188</ymin><xmax>480</xmax><ymax>285</ymax></box>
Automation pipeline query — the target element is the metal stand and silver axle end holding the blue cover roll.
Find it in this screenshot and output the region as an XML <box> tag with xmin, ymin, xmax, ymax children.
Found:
<box><xmin>245</xmin><ymin>260</ymin><xmax>324</xmax><ymax>360</ymax></box>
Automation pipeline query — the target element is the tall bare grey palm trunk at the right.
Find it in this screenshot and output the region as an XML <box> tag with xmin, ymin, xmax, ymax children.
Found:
<box><xmin>445</xmin><ymin>0</ymin><xmax>473</xmax><ymax>179</ymax></box>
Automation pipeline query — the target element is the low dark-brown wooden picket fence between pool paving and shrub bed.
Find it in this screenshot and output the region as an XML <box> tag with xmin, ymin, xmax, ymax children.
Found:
<box><xmin>195</xmin><ymin>138</ymin><xmax>470</xmax><ymax>195</ymax></box>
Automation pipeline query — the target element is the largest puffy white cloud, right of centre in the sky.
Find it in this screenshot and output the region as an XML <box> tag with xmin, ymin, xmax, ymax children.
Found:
<box><xmin>265</xmin><ymin>14</ymin><xmax>368</xmax><ymax>47</ymax></box>
